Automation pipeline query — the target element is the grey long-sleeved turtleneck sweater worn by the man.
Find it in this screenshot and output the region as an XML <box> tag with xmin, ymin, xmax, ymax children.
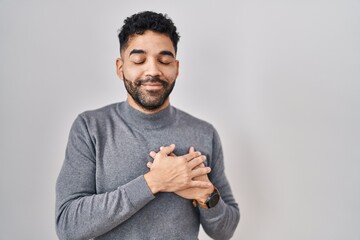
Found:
<box><xmin>56</xmin><ymin>102</ymin><xmax>240</xmax><ymax>240</ymax></box>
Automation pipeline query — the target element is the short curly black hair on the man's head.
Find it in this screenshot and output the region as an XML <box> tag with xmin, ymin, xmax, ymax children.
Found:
<box><xmin>118</xmin><ymin>11</ymin><xmax>180</xmax><ymax>53</ymax></box>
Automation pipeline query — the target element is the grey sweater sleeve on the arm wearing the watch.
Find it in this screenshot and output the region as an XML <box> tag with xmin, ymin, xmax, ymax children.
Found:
<box><xmin>199</xmin><ymin>130</ymin><xmax>240</xmax><ymax>240</ymax></box>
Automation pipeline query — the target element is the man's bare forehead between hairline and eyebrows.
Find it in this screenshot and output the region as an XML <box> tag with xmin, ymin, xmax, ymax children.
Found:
<box><xmin>124</xmin><ymin>30</ymin><xmax>175</xmax><ymax>56</ymax></box>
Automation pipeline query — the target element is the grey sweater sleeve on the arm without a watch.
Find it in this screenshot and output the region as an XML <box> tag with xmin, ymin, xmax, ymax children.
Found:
<box><xmin>56</xmin><ymin>116</ymin><xmax>154</xmax><ymax>239</ymax></box>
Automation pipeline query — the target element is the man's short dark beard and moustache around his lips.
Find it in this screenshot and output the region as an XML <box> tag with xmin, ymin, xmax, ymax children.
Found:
<box><xmin>123</xmin><ymin>75</ymin><xmax>175</xmax><ymax>111</ymax></box>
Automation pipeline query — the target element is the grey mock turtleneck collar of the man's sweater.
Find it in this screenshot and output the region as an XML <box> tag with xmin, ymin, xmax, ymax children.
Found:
<box><xmin>119</xmin><ymin>101</ymin><xmax>176</xmax><ymax>130</ymax></box>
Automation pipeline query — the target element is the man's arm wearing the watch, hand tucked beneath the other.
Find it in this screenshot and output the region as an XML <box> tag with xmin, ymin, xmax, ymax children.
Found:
<box><xmin>147</xmin><ymin>130</ymin><xmax>240</xmax><ymax>240</ymax></box>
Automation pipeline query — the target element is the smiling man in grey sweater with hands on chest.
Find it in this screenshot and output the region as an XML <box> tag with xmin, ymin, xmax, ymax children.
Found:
<box><xmin>56</xmin><ymin>12</ymin><xmax>240</xmax><ymax>240</ymax></box>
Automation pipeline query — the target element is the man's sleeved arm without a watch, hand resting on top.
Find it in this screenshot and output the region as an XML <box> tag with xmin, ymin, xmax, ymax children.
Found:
<box><xmin>56</xmin><ymin>116</ymin><xmax>209</xmax><ymax>239</ymax></box>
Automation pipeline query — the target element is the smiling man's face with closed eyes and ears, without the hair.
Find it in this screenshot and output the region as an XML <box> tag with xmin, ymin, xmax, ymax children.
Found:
<box><xmin>116</xmin><ymin>31</ymin><xmax>179</xmax><ymax>111</ymax></box>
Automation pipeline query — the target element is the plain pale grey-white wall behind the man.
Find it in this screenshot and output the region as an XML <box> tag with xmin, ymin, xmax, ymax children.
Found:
<box><xmin>0</xmin><ymin>0</ymin><xmax>360</xmax><ymax>240</ymax></box>
